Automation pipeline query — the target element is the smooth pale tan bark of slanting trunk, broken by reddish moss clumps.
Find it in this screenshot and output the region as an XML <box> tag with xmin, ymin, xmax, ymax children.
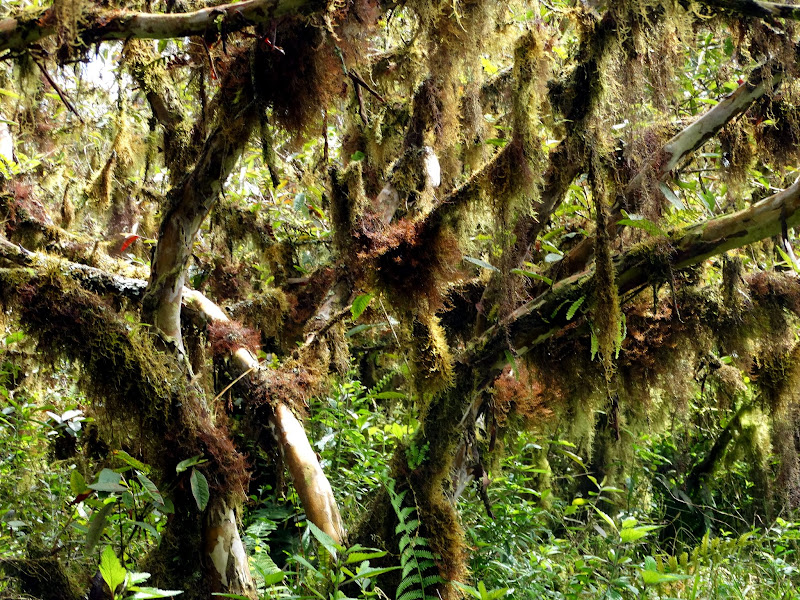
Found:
<box><xmin>184</xmin><ymin>290</ymin><xmax>345</xmax><ymax>543</ymax></box>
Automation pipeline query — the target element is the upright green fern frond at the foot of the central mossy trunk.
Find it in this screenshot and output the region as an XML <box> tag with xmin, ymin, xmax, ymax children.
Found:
<box><xmin>387</xmin><ymin>479</ymin><xmax>444</xmax><ymax>600</ymax></box>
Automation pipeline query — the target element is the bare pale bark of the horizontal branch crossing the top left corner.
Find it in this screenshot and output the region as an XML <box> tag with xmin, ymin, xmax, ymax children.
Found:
<box><xmin>0</xmin><ymin>0</ymin><xmax>325</xmax><ymax>53</ymax></box>
